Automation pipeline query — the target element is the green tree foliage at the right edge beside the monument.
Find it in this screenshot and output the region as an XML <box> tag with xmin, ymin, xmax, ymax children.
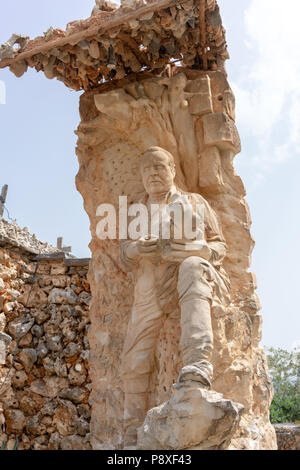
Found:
<box><xmin>267</xmin><ymin>348</ymin><xmax>300</xmax><ymax>424</ymax></box>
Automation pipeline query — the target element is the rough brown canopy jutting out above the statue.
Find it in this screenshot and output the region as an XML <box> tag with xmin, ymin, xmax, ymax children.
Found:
<box><xmin>0</xmin><ymin>0</ymin><xmax>229</xmax><ymax>90</ymax></box>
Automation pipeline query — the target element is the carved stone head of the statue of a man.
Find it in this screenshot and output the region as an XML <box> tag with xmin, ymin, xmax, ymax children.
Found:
<box><xmin>140</xmin><ymin>147</ymin><xmax>176</xmax><ymax>195</ymax></box>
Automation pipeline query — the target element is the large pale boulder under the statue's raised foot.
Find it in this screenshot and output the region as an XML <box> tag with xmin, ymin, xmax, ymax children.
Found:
<box><xmin>137</xmin><ymin>382</ymin><xmax>243</xmax><ymax>450</ymax></box>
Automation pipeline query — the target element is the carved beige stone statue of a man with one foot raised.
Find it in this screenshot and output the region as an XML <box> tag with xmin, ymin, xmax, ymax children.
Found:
<box><xmin>120</xmin><ymin>147</ymin><xmax>229</xmax><ymax>448</ymax></box>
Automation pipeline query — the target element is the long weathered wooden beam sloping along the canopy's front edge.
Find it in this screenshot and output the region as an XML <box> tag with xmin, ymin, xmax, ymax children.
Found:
<box><xmin>0</xmin><ymin>0</ymin><xmax>188</xmax><ymax>68</ymax></box>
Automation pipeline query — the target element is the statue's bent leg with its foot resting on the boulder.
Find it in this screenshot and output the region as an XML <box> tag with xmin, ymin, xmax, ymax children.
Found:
<box><xmin>177</xmin><ymin>256</ymin><xmax>213</xmax><ymax>386</ymax></box>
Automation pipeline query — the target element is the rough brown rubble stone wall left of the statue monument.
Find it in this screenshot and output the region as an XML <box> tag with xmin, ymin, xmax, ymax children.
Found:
<box><xmin>0</xmin><ymin>244</ymin><xmax>91</xmax><ymax>450</ymax></box>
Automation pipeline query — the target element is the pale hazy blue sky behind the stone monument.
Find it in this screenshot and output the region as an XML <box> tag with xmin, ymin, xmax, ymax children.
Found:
<box><xmin>0</xmin><ymin>0</ymin><xmax>300</xmax><ymax>349</ymax></box>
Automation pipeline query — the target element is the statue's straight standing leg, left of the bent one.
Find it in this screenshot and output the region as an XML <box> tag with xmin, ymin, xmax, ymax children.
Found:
<box><xmin>122</xmin><ymin>293</ymin><xmax>163</xmax><ymax>448</ymax></box>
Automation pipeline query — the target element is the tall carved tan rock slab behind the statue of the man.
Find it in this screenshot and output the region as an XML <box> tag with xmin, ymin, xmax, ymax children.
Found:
<box><xmin>76</xmin><ymin>68</ymin><xmax>276</xmax><ymax>449</ymax></box>
